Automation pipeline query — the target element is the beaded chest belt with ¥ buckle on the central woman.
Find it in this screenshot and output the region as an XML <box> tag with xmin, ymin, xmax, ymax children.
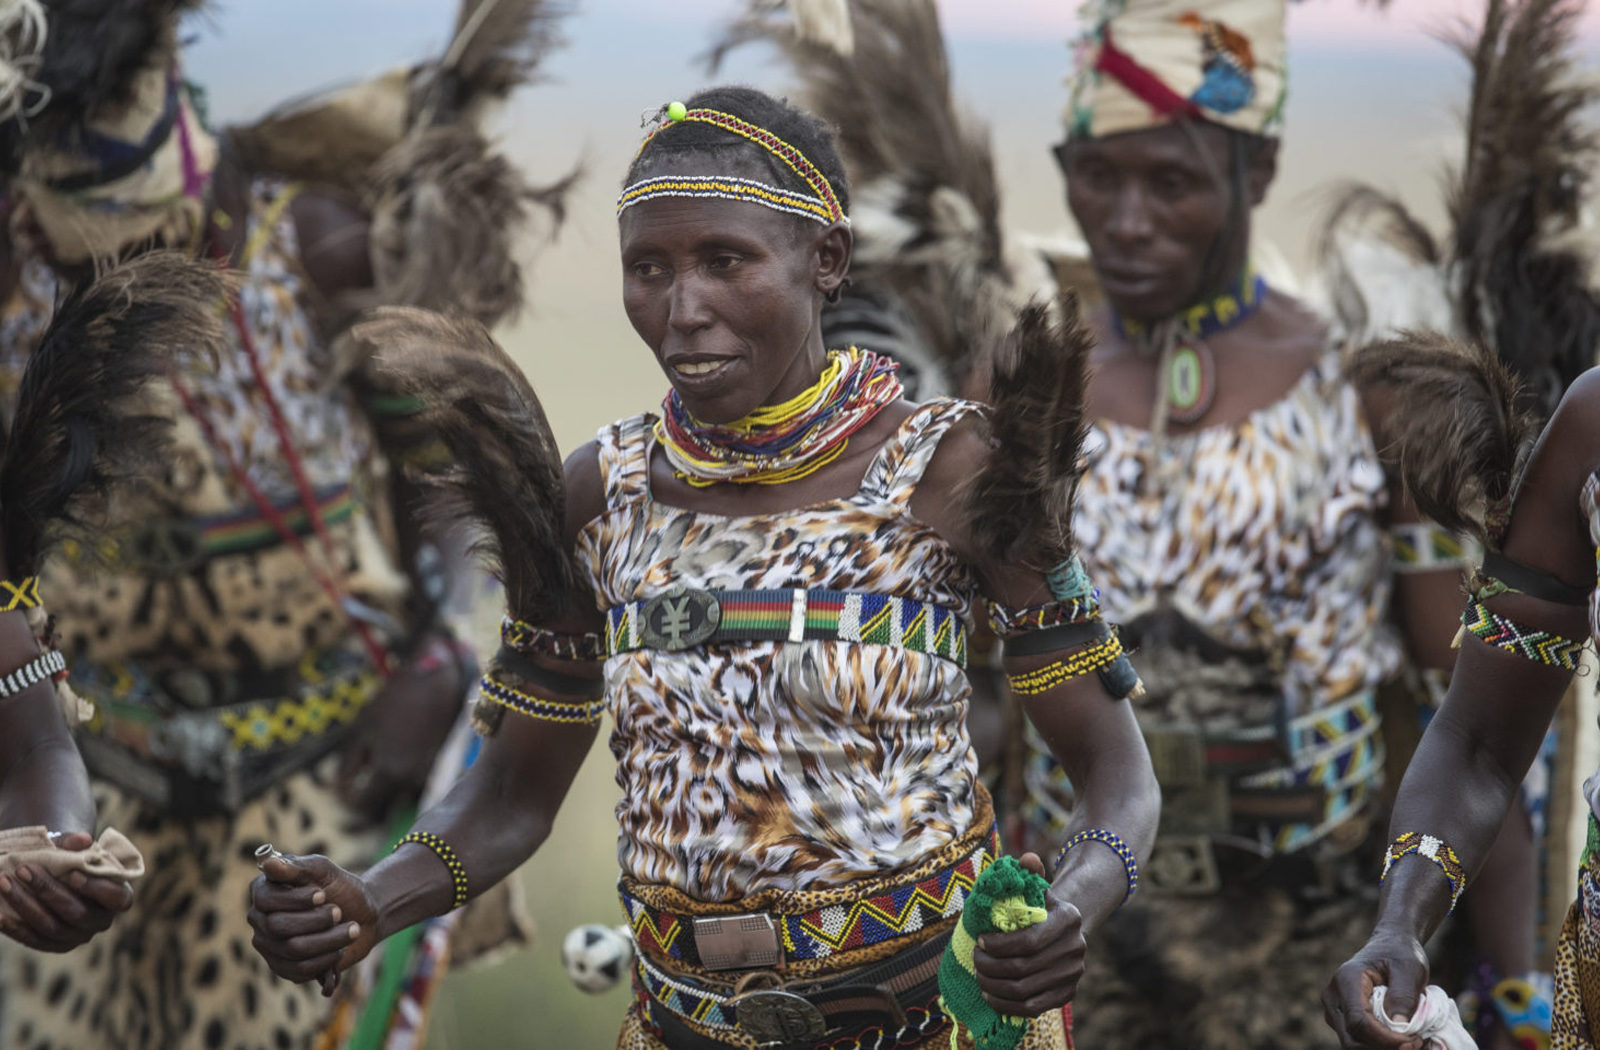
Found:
<box><xmin>606</xmin><ymin>587</ymin><xmax>966</xmax><ymax>667</ymax></box>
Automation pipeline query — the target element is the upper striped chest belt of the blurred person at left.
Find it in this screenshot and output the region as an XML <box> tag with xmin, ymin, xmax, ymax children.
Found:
<box><xmin>91</xmin><ymin>485</ymin><xmax>358</xmax><ymax>576</ymax></box>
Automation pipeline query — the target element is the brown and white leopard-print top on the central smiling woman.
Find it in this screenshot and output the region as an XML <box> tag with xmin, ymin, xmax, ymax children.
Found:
<box><xmin>578</xmin><ymin>400</ymin><xmax>978</xmax><ymax>901</ymax></box>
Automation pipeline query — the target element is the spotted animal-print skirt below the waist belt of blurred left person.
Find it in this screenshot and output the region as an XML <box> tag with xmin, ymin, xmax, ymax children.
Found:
<box><xmin>0</xmin><ymin>762</ymin><xmax>381</xmax><ymax>1050</ymax></box>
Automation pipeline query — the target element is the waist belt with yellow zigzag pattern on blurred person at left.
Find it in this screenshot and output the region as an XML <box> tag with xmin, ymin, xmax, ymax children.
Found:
<box><xmin>72</xmin><ymin>648</ymin><xmax>379</xmax><ymax>816</ymax></box>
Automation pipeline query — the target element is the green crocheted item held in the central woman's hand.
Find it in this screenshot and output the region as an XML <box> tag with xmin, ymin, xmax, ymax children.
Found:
<box><xmin>939</xmin><ymin>856</ymin><xmax>1050</xmax><ymax>1050</ymax></box>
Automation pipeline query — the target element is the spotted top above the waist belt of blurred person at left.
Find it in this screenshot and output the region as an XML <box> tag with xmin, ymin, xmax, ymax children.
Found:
<box><xmin>0</xmin><ymin>179</ymin><xmax>406</xmax><ymax>672</ymax></box>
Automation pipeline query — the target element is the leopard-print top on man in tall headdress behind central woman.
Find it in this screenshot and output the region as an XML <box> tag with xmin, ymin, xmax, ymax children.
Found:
<box><xmin>1074</xmin><ymin>352</ymin><xmax>1402</xmax><ymax>730</ymax></box>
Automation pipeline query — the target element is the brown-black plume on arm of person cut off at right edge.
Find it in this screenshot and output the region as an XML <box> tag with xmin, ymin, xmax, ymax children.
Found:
<box><xmin>1346</xmin><ymin>331</ymin><xmax>1536</xmax><ymax>546</ymax></box>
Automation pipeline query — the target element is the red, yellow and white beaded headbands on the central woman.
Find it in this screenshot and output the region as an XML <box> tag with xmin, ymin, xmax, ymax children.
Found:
<box><xmin>616</xmin><ymin>102</ymin><xmax>850</xmax><ymax>226</ymax></box>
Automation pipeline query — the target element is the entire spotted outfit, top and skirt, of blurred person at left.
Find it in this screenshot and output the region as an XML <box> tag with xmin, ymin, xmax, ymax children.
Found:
<box><xmin>0</xmin><ymin>182</ymin><xmax>405</xmax><ymax>1050</ymax></box>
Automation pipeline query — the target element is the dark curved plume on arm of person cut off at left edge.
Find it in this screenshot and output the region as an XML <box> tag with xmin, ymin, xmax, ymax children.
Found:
<box><xmin>0</xmin><ymin>251</ymin><xmax>234</xmax><ymax>575</ymax></box>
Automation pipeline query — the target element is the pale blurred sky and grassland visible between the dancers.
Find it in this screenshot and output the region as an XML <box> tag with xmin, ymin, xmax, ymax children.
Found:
<box><xmin>186</xmin><ymin>0</ymin><xmax>1600</xmax><ymax>1050</ymax></box>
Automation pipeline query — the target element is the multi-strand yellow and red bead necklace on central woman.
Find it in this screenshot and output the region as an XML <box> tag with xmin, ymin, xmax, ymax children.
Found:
<box><xmin>656</xmin><ymin>347</ymin><xmax>901</xmax><ymax>488</ymax></box>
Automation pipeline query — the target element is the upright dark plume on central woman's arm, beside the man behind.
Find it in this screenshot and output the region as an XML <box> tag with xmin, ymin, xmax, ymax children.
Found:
<box><xmin>966</xmin><ymin>293</ymin><xmax>1094</xmax><ymax>571</ymax></box>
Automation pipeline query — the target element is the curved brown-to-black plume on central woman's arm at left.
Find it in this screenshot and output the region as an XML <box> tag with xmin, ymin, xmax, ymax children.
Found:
<box><xmin>350</xmin><ymin>307</ymin><xmax>573</xmax><ymax>623</ymax></box>
